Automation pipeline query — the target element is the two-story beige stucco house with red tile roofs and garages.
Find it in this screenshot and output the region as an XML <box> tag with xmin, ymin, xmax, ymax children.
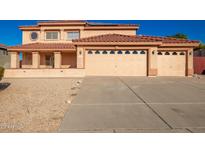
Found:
<box><xmin>7</xmin><ymin>20</ymin><xmax>199</xmax><ymax>77</ymax></box>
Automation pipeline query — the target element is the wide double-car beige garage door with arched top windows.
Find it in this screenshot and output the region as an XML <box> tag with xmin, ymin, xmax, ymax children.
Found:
<box><xmin>85</xmin><ymin>50</ymin><xmax>147</xmax><ymax>76</ymax></box>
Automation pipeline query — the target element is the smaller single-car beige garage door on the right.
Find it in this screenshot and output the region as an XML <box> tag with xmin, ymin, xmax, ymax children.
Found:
<box><xmin>157</xmin><ymin>52</ymin><xmax>186</xmax><ymax>76</ymax></box>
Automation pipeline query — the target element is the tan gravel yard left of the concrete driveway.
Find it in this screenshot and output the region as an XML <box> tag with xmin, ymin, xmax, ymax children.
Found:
<box><xmin>0</xmin><ymin>78</ymin><xmax>82</xmax><ymax>132</ymax></box>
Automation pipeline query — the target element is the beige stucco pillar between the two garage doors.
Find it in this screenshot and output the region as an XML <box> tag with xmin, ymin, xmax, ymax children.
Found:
<box><xmin>147</xmin><ymin>47</ymin><xmax>158</xmax><ymax>76</ymax></box>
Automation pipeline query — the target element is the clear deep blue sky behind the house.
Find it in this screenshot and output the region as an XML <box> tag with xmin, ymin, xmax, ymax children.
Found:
<box><xmin>0</xmin><ymin>20</ymin><xmax>205</xmax><ymax>45</ymax></box>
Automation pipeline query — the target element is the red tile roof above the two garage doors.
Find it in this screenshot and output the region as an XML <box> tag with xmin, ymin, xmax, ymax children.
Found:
<box><xmin>73</xmin><ymin>34</ymin><xmax>199</xmax><ymax>43</ymax></box>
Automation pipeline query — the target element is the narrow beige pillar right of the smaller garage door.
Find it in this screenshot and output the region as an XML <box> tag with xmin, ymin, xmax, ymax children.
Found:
<box><xmin>186</xmin><ymin>48</ymin><xmax>194</xmax><ymax>76</ymax></box>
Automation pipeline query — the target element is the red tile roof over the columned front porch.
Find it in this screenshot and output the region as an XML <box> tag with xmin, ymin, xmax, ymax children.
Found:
<box><xmin>8</xmin><ymin>43</ymin><xmax>75</xmax><ymax>50</ymax></box>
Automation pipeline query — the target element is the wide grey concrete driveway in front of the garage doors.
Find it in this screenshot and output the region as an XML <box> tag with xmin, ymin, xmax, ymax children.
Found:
<box><xmin>59</xmin><ymin>77</ymin><xmax>205</xmax><ymax>132</ymax></box>
